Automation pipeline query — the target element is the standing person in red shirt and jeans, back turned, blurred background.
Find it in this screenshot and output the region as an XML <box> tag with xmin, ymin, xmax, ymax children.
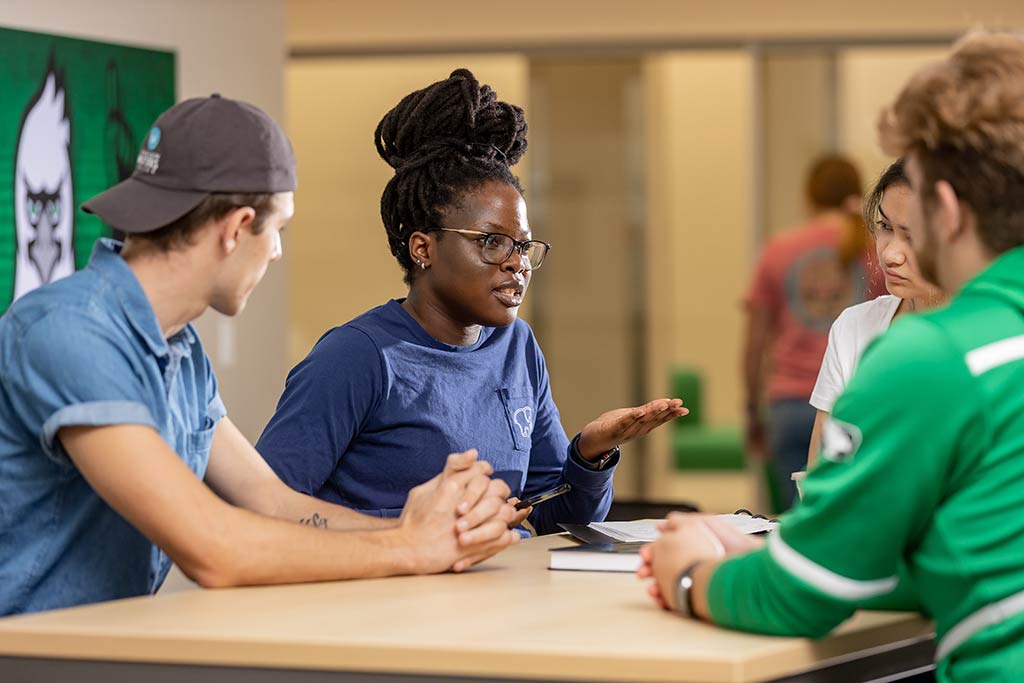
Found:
<box><xmin>743</xmin><ymin>156</ymin><xmax>873</xmax><ymax>508</ymax></box>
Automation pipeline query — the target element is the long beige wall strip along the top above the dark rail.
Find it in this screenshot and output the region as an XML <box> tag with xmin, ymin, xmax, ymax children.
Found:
<box><xmin>288</xmin><ymin>0</ymin><xmax>1024</xmax><ymax>51</ymax></box>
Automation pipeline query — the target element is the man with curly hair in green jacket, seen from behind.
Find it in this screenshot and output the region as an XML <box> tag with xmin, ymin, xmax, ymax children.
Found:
<box><xmin>639</xmin><ymin>34</ymin><xmax>1024</xmax><ymax>682</ymax></box>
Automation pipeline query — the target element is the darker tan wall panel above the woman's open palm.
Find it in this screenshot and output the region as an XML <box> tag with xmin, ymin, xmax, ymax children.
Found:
<box><xmin>526</xmin><ymin>57</ymin><xmax>643</xmax><ymax>498</ymax></box>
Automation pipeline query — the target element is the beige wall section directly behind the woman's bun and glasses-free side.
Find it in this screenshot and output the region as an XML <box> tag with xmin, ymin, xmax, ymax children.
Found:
<box><xmin>285</xmin><ymin>55</ymin><xmax>528</xmax><ymax>364</ymax></box>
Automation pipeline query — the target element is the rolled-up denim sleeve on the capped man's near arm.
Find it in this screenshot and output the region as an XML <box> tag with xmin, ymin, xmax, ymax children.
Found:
<box><xmin>2</xmin><ymin>311</ymin><xmax>158</xmax><ymax>463</ymax></box>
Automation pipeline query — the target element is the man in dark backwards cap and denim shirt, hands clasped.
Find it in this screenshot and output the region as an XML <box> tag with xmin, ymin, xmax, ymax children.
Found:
<box><xmin>0</xmin><ymin>95</ymin><xmax>518</xmax><ymax>614</ymax></box>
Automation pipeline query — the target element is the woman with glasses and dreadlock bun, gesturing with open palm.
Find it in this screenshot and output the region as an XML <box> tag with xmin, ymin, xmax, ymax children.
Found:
<box><xmin>258</xmin><ymin>69</ymin><xmax>687</xmax><ymax>533</ymax></box>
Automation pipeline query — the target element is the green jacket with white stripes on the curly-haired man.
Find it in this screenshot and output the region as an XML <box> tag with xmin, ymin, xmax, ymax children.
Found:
<box><xmin>709</xmin><ymin>247</ymin><xmax>1024</xmax><ymax>683</ymax></box>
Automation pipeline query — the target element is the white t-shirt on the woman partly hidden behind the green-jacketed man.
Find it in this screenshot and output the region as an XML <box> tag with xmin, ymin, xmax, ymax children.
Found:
<box><xmin>811</xmin><ymin>294</ymin><xmax>902</xmax><ymax>413</ymax></box>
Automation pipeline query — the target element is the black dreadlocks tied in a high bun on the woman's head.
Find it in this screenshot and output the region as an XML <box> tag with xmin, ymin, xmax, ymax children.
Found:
<box><xmin>374</xmin><ymin>69</ymin><xmax>526</xmax><ymax>283</ymax></box>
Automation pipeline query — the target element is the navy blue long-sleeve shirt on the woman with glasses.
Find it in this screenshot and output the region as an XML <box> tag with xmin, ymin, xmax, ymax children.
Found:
<box><xmin>256</xmin><ymin>300</ymin><xmax>614</xmax><ymax>533</ymax></box>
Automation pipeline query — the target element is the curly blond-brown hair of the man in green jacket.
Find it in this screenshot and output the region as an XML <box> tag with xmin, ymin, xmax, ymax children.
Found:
<box><xmin>879</xmin><ymin>32</ymin><xmax>1024</xmax><ymax>254</ymax></box>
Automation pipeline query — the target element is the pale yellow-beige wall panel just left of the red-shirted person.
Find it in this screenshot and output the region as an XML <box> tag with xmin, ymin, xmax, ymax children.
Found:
<box><xmin>645</xmin><ymin>51</ymin><xmax>754</xmax><ymax>509</ymax></box>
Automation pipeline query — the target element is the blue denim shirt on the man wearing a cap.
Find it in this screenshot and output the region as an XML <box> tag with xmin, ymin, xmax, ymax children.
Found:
<box><xmin>0</xmin><ymin>240</ymin><xmax>225</xmax><ymax>614</ymax></box>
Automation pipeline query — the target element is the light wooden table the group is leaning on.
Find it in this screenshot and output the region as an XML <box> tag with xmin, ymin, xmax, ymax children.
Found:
<box><xmin>0</xmin><ymin>537</ymin><xmax>932</xmax><ymax>683</ymax></box>
